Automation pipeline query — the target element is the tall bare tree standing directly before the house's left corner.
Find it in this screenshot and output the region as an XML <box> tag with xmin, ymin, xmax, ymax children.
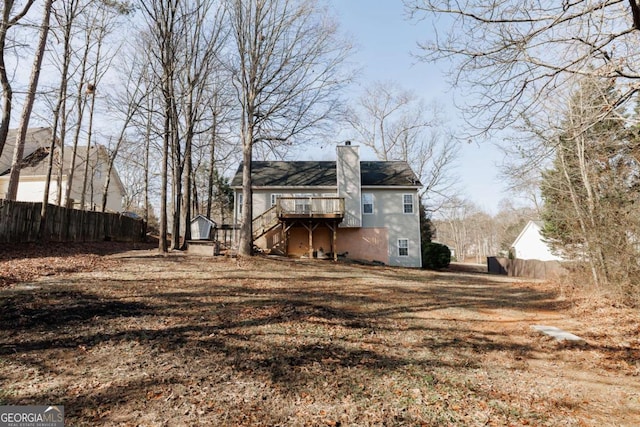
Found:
<box><xmin>224</xmin><ymin>0</ymin><xmax>349</xmax><ymax>255</ymax></box>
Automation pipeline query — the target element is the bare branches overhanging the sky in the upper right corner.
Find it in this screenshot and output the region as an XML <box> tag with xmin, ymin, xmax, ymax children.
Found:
<box><xmin>405</xmin><ymin>0</ymin><xmax>640</xmax><ymax>132</ymax></box>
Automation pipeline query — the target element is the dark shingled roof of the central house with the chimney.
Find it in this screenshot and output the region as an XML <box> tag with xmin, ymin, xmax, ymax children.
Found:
<box><xmin>231</xmin><ymin>161</ymin><xmax>421</xmax><ymax>187</ymax></box>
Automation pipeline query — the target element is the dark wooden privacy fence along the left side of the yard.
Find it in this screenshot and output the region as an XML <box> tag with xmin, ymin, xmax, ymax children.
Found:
<box><xmin>0</xmin><ymin>200</ymin><xmax>146</xmax><ymax>243</ymax></box>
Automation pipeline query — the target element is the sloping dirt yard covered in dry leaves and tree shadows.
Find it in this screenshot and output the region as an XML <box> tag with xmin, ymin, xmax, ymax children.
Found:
<box><xmin>0</xmin><ymin>247</ymin><xmax>640</xmax><ymax>426</ymax></box>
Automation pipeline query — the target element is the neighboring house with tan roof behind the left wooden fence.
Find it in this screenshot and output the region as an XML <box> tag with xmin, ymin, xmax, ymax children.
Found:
<box><xmin>0</xmin><ymin>127</ymin><xmax>125</xmax><ymax>212</ymax></box>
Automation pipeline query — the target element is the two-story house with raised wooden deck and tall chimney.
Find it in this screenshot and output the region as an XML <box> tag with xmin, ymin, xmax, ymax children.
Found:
<box><xmin>231</xmin><ymin>143</ymin><xmax>421</xmax><ymax>267</ymax></box>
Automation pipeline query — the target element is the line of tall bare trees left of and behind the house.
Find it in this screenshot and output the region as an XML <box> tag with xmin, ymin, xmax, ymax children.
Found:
<box><xmin>0</xmin><ymin>0</ymin><xmax>457</xmax><ymax>255</ymax></box>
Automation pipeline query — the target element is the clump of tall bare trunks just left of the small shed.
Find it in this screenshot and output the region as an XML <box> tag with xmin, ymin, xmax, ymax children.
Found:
<box><xmin>141</xmin><ymin>0</ymin><xmax>226</xmax><ymax>250</ymax></box>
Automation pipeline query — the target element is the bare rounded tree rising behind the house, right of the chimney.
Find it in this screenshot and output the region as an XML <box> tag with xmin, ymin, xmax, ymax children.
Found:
<box><xmin>348</xmin><ymin>82</ymin><xmax>460</xmax><ymax>212</ymax></box>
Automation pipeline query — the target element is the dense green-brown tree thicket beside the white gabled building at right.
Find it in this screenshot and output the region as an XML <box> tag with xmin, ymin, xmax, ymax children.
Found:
<box><xmin>541</xmin><ymin>78</ymin><xmax>640</xmax><ymax>301</ymax></box>
